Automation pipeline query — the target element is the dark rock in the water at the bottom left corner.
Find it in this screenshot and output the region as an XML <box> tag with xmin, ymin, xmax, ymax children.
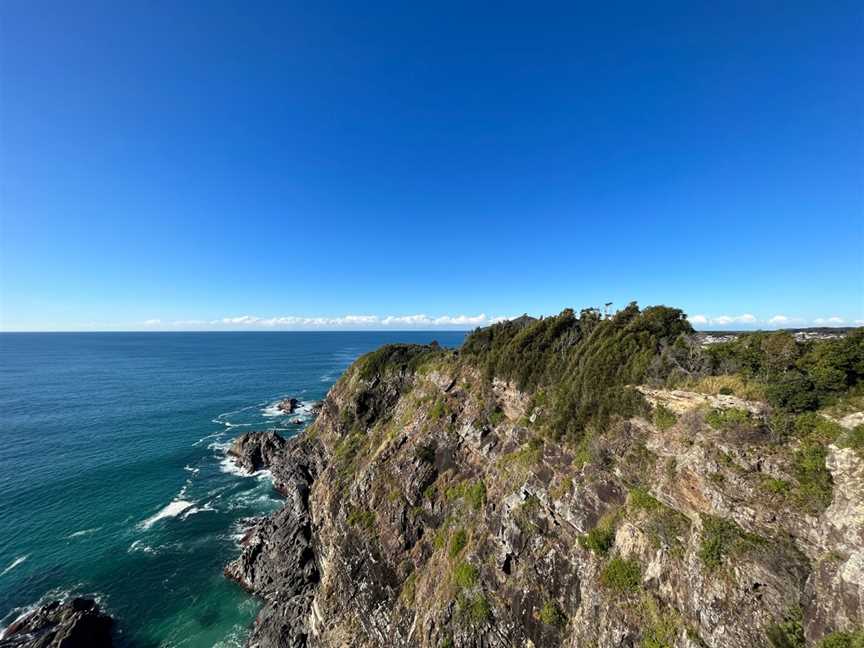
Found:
<box><xmin>0</xmin><ymin>598</ymin><xmax>112</xmax><ymax>648</ymax></box>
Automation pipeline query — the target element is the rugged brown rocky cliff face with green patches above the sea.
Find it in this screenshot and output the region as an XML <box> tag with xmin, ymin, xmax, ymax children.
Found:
<box><xmin>226</xmin><ymin>336</ymin><xmax>864</xmax><ymax>648</ymax></box>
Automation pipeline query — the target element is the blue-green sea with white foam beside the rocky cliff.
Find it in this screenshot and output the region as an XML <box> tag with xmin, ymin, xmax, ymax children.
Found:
<box><xmin>0</xmin><ymin>331</ymin><xmax>464</xmax><ymax>648</ymax></box>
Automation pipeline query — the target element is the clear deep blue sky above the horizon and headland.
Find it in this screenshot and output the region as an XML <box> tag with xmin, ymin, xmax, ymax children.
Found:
<box><xmin>0</xmin><ymin>0</ymin><xmax>864</xmax><ymax>330</ymax></box>
